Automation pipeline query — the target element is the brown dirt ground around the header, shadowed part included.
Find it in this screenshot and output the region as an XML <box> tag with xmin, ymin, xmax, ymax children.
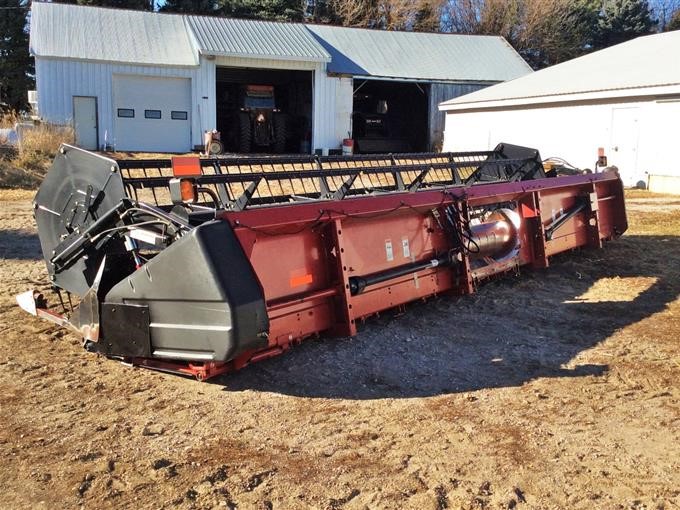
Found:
<box><xmin>0</xmin><ymin>190</ymin><xmax>680</xmax><ymax>509</ymax></box>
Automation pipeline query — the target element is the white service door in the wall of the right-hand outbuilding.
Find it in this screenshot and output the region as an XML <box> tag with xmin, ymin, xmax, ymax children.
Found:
<box><xmin>608</xmin><ymin>107</ymin><xmax>646</xmax><ymax>187</ymax></box>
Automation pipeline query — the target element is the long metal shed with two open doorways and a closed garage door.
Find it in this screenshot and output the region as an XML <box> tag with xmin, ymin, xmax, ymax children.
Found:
<box><xmin>30</xmin><ymin>1</ymin><xmax>531</xmax><ymax>152</ymax></box>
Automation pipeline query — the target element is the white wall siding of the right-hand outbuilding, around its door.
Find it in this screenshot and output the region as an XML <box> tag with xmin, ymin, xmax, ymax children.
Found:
<box><xmin>444</xmin><ymin>95</ymin><xmax>680</xmax><ymax>185</ymax></box>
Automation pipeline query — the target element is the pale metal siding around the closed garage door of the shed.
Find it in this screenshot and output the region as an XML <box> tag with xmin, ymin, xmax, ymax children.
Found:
<box><xmin>35</xmin><ymin>57</ymin><xmax>207</xmax><ymax>146</ymax></box>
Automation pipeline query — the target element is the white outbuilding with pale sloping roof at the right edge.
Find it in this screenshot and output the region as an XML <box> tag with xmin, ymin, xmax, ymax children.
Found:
<box><xmin>440</xmin><ymin>31</ymin><xmax>680</xmax><ymax>192</ymax></box>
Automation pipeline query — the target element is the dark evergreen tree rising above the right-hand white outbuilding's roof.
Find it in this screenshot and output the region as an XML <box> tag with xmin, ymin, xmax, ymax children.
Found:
<box><xmin>593</xmin><ymin>0</ymin><xmax>656</xmax><ymax>49</ymax></box>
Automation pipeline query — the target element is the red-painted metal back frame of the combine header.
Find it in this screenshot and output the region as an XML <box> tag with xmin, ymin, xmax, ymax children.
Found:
<box><xmin>137</xmin><ymin>173</ymin><xmax>627</xmax><ymax>378</ymax></box>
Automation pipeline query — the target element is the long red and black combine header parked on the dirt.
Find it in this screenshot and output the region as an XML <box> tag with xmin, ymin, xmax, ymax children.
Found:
<box><xmin>18</xmin><ymin>144</ymin><xmax>627</xmax><ymax>380</ymax></box>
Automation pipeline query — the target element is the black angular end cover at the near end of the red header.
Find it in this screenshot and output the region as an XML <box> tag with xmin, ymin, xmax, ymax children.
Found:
<box><xmin>100</xmin><ymin>221</ymin><xmax>269</xmax><ymax>361</ymax></box>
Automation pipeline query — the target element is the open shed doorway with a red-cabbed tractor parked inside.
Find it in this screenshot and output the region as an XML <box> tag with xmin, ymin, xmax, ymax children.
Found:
<box><xmin>216</xmin><ymin>67</ymin><xmax>313</xmax><ymax>154</ymax></box>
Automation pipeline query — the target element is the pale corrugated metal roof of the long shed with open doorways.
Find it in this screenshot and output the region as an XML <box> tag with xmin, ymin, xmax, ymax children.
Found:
<box><xmin>31</xmin><ymin>1</ymin><xmax>531</xmax><ymax>83</ymax></box>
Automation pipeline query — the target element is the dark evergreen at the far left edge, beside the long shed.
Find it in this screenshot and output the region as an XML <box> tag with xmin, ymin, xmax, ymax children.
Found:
<box><xmin>0</xmin><ymin>0</ymin><xmax>33</xmax><ymax>111</ymax></box>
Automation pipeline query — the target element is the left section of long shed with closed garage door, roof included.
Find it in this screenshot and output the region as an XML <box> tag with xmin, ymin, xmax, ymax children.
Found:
<box><xmin>31</xmin><ymin>2</ymin><xmax>203</xmax><ymax>152</ymax></box>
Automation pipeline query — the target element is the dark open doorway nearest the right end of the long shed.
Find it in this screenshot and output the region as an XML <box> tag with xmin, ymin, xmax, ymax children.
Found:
<box><xmin>352</xmin><ymin>78</ymin><xmax>429</xmax><ymax>154</ymax></box>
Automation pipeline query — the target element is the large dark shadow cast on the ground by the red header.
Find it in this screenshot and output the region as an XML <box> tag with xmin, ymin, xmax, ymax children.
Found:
<box><xmin>219</xmin><ymin>236</ymin><xmax>680</xmax><ymax>399</ymax></box>
